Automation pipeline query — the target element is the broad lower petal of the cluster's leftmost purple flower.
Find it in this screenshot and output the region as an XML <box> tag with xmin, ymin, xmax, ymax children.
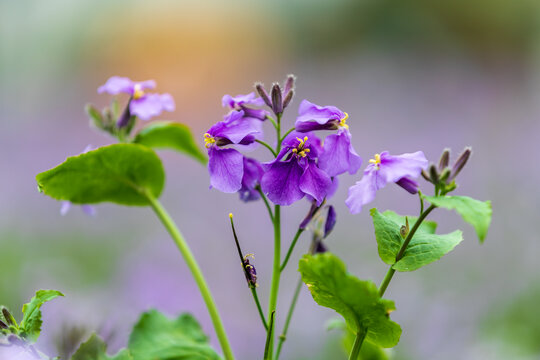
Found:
<box><xmin>208</xmin><ymin>146</ymin><xmax>244</xmax><ymax>193</ymax></box>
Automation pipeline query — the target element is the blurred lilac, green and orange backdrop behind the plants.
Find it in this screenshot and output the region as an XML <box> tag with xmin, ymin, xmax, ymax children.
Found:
<box><xmin>0</xmin><ymin>0</ymin><xmax>540</xmax><ymax>360</ymax></box>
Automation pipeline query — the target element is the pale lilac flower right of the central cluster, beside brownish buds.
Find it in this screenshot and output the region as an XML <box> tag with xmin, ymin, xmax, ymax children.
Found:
<box><xmin>345</xmin><ymin>151</ymin><xmax>428</xmax><ymax>214</ymax></box>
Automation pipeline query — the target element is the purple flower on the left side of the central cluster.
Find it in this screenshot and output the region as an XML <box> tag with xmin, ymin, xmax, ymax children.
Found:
<box><xmin>204</xmin><ymin>111</ymin><xmax>261</xmax><ymax>193</ymax></box>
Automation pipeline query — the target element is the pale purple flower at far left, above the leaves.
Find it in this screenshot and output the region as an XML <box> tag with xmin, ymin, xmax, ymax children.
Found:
<box><xmin>98</xmin><ymin>76</ymin><xmax>175</xmax><ymax>120</ymax></box>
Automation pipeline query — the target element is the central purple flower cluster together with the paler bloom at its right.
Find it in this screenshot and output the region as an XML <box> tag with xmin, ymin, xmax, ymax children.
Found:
<box><xmin>204</xmin><ymin>75</ymin><xmax>428</xmax><ymax>213</ymax></box>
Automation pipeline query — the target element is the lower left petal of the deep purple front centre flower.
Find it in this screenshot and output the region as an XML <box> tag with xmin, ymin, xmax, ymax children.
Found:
<box><xmin>261</xmin><ymin>159</ymin><xmax>304</xmax><ymax>206</ymax></box>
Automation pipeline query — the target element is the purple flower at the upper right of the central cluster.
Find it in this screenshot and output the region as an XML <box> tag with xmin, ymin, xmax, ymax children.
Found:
<box><xmin>295</xmin><ymin>100</ymin><xmax>362</xmax><ymax>177</ymax></box>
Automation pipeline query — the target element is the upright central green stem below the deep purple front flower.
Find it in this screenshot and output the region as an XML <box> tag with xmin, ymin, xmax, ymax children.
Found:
<box><xmin>266</xmin><ymin>205</ymin><xmax>281</xmax><ymax>359</ymax></box>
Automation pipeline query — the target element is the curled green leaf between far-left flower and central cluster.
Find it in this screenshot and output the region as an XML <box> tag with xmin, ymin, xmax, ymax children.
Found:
<box><xmin>133</xmin><ymin>121</ymin><xmax>208</xmax><ymax>165</ymax></box>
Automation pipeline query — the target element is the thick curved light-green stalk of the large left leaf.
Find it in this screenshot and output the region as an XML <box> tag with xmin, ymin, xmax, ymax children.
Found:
<box><xmin>144</xmin><ymin>192</ymin><xmax>234</xmax><ymax>360</ymax></box>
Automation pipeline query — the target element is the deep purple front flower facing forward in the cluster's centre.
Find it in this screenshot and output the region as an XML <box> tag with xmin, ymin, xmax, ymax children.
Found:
<box><xmin>261</xmin><ymin>131</ymin><xmax>332</xmax><ymax>205</ymax></box>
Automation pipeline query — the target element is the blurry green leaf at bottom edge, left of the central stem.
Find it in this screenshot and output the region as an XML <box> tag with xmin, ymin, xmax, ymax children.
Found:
<box><xmin>128</xmin><ymin>310</ymin><xmax>219</xmax><ymax>360</ymax></box>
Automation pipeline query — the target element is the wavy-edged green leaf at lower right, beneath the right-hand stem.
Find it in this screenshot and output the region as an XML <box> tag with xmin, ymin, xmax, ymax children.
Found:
<box><xmin>299</xmin><ymin>253</ymin><xmax>401</xmax><ymax>347</ymax></box>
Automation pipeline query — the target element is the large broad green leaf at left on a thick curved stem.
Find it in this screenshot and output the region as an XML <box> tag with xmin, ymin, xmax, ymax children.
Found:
<box><xmin>36</xmin><ymin>144</ymin><xmax>165</xmax><ymax>206</ymax></box>
